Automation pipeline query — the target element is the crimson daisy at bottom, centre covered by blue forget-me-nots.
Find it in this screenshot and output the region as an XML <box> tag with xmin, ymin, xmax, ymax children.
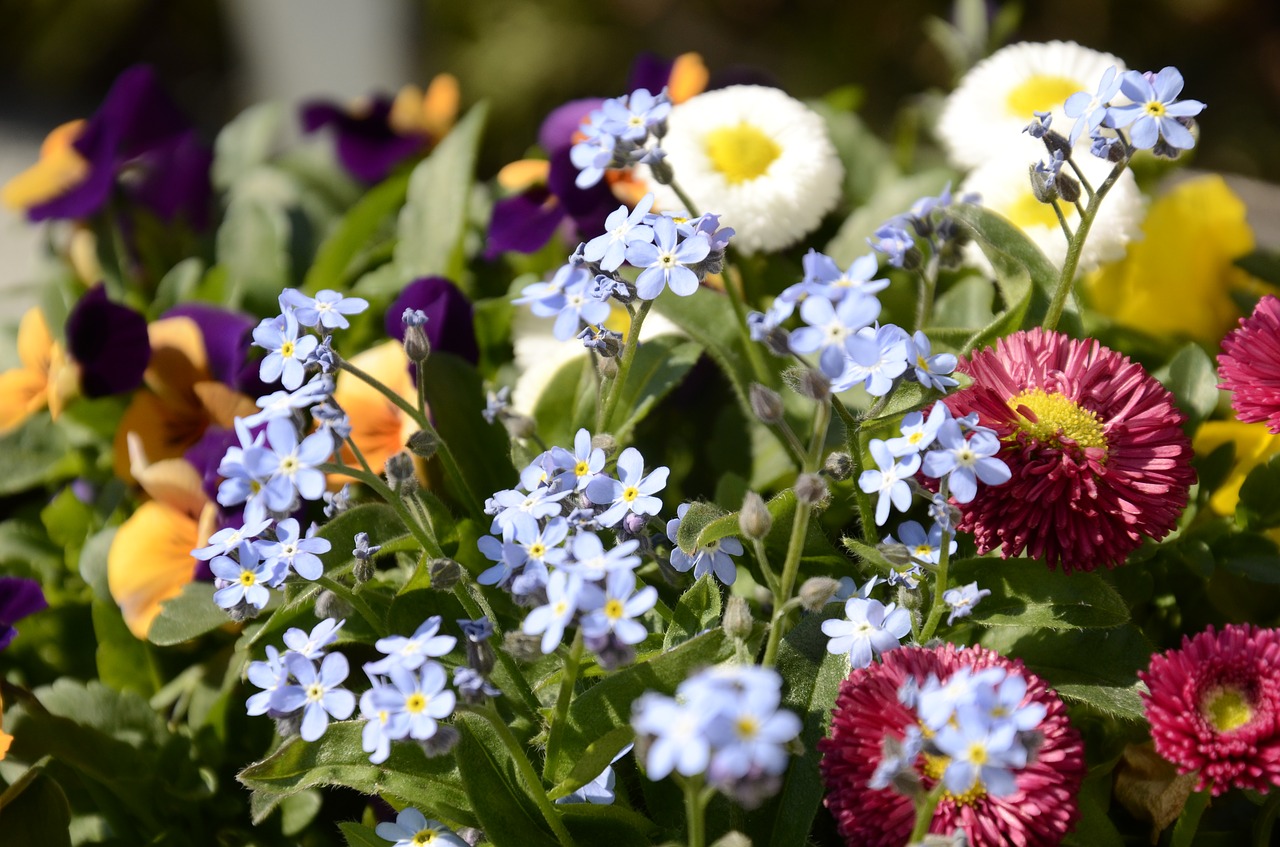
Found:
<box><xmin>818</xmin><ymin>644</ymin><xmax>1085</xmax><ymax>847</ymax></box>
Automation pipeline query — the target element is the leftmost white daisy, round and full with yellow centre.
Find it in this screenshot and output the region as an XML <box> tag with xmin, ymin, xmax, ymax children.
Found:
<box><xmin>645</xmin><ymin>86</ymin><xmax>845</xmax><ymax>253</ymax></box>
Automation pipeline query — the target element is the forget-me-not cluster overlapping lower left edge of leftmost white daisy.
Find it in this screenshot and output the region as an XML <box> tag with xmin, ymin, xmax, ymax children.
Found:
<box><xmin>513</xmin><ymin>194</ymin><xmax>733</xmax><ymax>345</ymax></box>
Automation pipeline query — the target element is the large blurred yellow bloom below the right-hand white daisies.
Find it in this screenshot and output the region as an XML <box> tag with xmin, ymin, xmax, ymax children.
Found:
<box><xmin>1084</xmin><ymin>175</ymin><xmax>1257</xmax><ymax>344</ymax></box>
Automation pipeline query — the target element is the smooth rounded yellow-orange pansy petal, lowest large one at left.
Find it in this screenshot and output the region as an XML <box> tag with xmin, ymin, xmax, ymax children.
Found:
<box><xmin>106</xmin><ymin>500</ymin><xmax>200</xmax><ymax>638</ymax></box>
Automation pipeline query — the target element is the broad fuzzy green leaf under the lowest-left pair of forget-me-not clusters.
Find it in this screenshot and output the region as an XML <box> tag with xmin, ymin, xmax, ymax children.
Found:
<box><xmin>238</xmin><ymin>720</ymin><xmax>476</xmax><ymax>827</ymax></box>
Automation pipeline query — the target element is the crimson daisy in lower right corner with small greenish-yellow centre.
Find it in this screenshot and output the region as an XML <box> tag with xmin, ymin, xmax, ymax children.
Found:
<box><xmin>1138</xmin><ymin>623</ymin><xmax>1280</xmax><ymax>796</ymax></box>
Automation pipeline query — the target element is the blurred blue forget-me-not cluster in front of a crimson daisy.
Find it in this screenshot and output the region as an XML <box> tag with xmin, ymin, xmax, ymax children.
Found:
<box><xmin>869</xmin><ymin>668</ymin><xmax>1046</xmax><ymax>797</ymax></box>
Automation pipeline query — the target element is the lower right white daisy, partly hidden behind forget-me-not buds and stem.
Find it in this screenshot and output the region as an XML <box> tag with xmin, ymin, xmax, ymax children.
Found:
<box><xmin>960</xmin><ymin>144</ymin><xmax>1144</xmax><ymax>274</ymax></box>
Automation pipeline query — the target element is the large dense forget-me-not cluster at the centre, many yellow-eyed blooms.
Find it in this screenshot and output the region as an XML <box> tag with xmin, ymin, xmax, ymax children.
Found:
<box><xmin>477</xmin><ymin>429</ymin><xmax>668</xmax><ymax>667</ymax></box>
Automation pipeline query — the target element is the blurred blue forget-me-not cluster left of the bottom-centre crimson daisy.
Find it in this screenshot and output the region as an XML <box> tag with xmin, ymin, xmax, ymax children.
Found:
<box><xmin>631</xmin><ymin>665</ymin><xmax>801</xmax><ymax>809</ymax></box>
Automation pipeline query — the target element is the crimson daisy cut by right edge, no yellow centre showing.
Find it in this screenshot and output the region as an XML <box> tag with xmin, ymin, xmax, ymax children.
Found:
<box><xmin>1217</xmin><ymin>294</ymin><xmax>1280</xmax><ymax>434</ymax></box>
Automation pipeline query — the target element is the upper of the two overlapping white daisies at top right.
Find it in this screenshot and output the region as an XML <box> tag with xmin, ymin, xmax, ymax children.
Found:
<box><xmin>934</xmin><ymin>41</ymin><xmax>1125</xmax><ymax>168</ymax></box>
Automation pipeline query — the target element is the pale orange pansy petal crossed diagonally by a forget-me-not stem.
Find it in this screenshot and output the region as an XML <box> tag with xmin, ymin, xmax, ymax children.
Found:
<box><xmin>330</xmin><ymin>342</ymin><xmax>417</xmax><ymax>485</ymax></box>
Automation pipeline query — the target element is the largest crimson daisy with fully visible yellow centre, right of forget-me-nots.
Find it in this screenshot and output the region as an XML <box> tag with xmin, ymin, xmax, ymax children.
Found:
<box><xmin>946</xmin><ymin>329</ymin><xmax>1196</xmax><ymax>573</ymax></box>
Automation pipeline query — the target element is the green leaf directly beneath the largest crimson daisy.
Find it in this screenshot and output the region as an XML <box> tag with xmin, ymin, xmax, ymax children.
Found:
<box><xmin>951</xmin><ymin>558</ymin><xmax>1129</xmax><ymax>629</ymax></box>
